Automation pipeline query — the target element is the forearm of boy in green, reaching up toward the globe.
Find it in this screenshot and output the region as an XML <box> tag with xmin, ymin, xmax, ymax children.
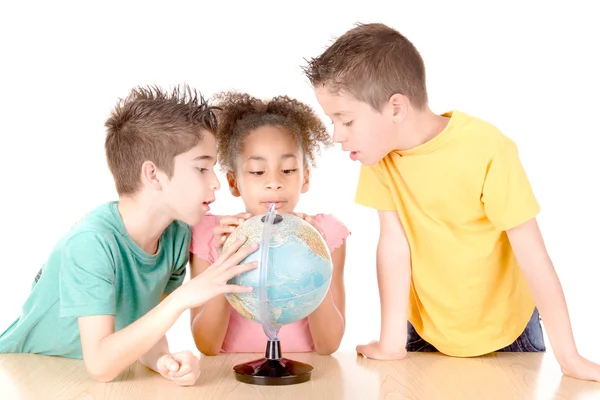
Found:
<box><xmin>84</xmin><ymin>296</ymin><xmax>184</xmax><ymax>381</ymax></box>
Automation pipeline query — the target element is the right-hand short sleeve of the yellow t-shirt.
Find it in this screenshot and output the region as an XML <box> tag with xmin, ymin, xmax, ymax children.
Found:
<box><xmin>481</xmin><ymin>137</ymin><xmax>540</xmax><ymax>231</ymax></box>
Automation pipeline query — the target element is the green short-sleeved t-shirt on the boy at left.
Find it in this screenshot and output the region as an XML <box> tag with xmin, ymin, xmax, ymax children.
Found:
<box><xmin>0</xmin><ymin>202</ymin><xmax>191</xmax><ymax>358</ymax></box>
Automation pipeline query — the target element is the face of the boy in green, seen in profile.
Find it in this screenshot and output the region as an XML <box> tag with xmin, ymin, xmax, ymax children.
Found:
<box><xmin>163</xmin><ymin>132</ymin><xmax>220</xmax><ymax>226</ymax></box>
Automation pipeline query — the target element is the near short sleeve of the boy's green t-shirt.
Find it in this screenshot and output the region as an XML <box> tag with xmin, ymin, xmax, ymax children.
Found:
<box><xmin>59</xmin><ymin>232</ymin><xmax>116</xmax><ymax>317</ymax></box>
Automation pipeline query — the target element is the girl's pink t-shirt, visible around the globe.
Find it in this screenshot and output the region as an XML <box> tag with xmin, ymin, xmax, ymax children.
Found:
<box><xmin>190</xmin><ymin>214</ymin><xmax>350</xmax><ymax>353</ymax></box>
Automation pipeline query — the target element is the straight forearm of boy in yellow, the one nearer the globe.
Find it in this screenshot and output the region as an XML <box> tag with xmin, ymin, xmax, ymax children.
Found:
<box><xmin>377</xmin><ymin>243</ymin><xmax>411</xmax><ymax>352</ymax></box>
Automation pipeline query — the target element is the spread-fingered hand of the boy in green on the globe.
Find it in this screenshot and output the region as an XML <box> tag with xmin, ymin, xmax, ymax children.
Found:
<box><xmin>174</xmin><ymin>237</ymin><xmax>258</xmax><ymax>309</ymax></box>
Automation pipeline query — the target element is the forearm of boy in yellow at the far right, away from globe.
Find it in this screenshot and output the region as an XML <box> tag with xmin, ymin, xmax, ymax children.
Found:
<box><xmin>522</xmin><ymin>255</ymin><xmax>577</xmax><ymax>363</ymax></box>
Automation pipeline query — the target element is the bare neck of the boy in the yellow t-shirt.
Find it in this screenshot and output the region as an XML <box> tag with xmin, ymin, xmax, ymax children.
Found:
<box><xmin>395</xmin><ymin>107</ymin><xmax>449</xmax><ymax>151</ymax></box>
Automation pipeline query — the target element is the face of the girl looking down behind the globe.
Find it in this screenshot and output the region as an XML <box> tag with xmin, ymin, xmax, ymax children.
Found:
<box><xmin>227</xmin><ymin>126</ymin><xmax>309</xmax><ymax>215</ymax></box>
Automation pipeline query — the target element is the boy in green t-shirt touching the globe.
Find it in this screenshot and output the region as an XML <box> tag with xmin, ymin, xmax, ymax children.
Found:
<box><xmin>0</xmin><ymin>87</ymin><xmax>256</xmax><ymax>385</ymax></box>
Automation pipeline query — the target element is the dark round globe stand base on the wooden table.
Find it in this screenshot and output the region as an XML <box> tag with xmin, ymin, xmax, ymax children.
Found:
<box><xmin>233</xmin><ymin>339</ymin><xmax>314</xmax><ymax>386</ymax></box>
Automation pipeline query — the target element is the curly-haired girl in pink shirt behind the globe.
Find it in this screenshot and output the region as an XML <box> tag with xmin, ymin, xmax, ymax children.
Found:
<box><xmin>190</xmin><ymin>93</ymin><xmax>350</xmax><ymax>355</ymax></box>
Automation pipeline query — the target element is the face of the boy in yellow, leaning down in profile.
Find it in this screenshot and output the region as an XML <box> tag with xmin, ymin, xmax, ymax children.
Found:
<box><xmin>315</xmin><ymin>87</ymin><xmax>396</xmax><ymax>165</ymax></box>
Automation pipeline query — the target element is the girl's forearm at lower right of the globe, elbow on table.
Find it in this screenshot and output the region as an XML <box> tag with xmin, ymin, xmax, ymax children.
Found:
<box><xmin>308</xmin><ymin>291</ymin><xmax>346</xmax><ymax>354</ymax></box>
